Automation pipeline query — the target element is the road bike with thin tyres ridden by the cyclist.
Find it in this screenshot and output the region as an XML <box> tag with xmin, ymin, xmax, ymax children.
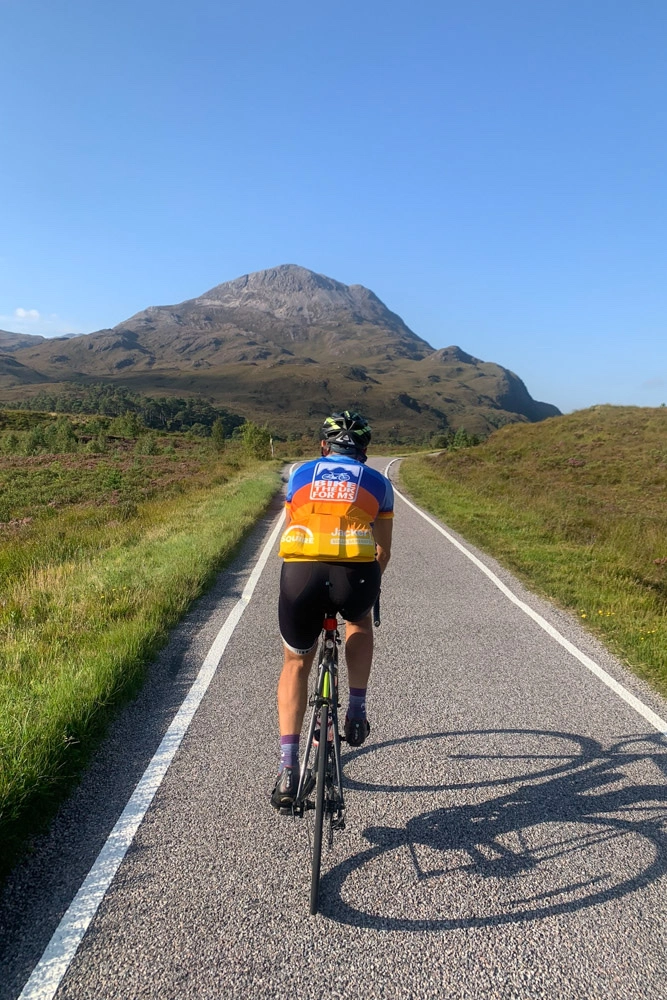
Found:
<box><xmin>292</xmin><ymin>598</ymin><xmax>380</xmax><ymax>915</ymax></box>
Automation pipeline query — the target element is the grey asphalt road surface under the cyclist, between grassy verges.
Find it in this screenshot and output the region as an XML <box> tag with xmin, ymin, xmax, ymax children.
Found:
<box><xmin>0</xmin><ymin>459</ymin><xmax>667</xmax><ymax>1000</ymax></box>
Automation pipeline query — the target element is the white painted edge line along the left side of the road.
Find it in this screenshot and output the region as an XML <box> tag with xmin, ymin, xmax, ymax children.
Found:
<box><xmin>19</xmin><ymin>514</ymin><xmax>283</xmax><ymax>1000</ymax></box>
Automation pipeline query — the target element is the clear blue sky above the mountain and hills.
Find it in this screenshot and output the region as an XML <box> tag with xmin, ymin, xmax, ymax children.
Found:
<box><xmin>0</xmin><ymin>0</ymin><xmax>667</xmax><ymax>411</ymax></box>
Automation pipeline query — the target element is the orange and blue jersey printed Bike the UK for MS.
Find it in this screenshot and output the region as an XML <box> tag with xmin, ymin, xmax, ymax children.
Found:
<box><xmin>280</xmin><ymin>455</ymin><xmax>394</xmax><ymax>562</ymax></box>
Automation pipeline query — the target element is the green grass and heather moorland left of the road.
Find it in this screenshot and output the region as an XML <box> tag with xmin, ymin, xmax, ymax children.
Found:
<box><xmin>0</xmin><ymin>412</ymin><xmax>279</xmax><ymax>875</ymax></box>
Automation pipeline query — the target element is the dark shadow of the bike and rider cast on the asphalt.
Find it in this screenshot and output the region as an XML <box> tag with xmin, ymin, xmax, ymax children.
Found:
<box><xmin>320</xmin><ymin>730</ymin><xmax>667</xmax><ymax>930</ymax></box>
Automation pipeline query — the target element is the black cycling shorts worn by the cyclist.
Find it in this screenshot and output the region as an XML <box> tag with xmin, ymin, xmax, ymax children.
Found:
<box><xmin>278</xmin><ymin>562</ymin><xmax>381</xmax><ymax>654</ymax></box>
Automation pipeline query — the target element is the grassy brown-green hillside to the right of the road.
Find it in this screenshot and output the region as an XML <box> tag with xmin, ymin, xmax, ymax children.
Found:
<box><xmin>401</xmin><ymin>406</ymin><xmax>667</xmax><ymax>694</ymax></box>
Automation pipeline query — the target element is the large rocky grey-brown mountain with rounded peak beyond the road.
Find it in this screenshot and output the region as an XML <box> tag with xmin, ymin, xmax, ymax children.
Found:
<box><xmin>0</xmin><ymin>264</ymin><xmax>559</xmax><ymax>438</ymax></box>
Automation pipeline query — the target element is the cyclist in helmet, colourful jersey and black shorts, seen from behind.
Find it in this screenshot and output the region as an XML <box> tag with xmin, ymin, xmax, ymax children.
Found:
<box><xmin>271</xmin><ymin>410</ymin><xmax>394</xmax><ymax>809</ymax></box>
